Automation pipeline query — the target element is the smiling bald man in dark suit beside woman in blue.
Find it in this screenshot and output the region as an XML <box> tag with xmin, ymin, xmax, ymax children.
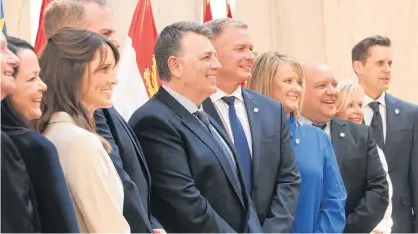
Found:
<box><xmin>301</xmin><ymin>64</ymin><xmax>389</xmax><ymax>233</ymax></box>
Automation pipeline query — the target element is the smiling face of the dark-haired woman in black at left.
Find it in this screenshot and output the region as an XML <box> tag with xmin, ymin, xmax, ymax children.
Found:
<box><xmin>10</xmin><ymin>49</ymin><xmax>47</xmax><ymax>120</ymax></box>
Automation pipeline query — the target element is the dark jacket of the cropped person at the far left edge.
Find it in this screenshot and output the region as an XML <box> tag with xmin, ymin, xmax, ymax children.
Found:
<box><xmin>1</xmin><ymin>131</ymin><xmax>37</xmax><ymax>233</ymax></box>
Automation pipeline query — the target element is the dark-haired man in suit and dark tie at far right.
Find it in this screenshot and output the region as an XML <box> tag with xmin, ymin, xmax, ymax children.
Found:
<box><xmin>351</xmin><ymin>36</ymin><xmax>418</xmax><ymax>233</ymax></box>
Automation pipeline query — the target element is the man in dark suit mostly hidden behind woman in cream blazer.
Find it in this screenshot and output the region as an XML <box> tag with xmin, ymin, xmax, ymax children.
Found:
<box><xmin>44</xmin><ymin>0</ymin><xmax>162</xmax><ymax>233</ymax></box>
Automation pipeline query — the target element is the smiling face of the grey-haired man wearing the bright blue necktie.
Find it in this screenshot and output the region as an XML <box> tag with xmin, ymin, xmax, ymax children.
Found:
<box><xmin>212</xmin><ymin>25</ymin><xmax>254</xmax><ymax>87</ymax></box>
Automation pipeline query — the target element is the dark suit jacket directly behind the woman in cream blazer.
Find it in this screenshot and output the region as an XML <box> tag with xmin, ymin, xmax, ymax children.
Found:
<box><xmin>94</xmin><ymin>107</ymin><xmax>157</xmax><ymax>233</ymax></box>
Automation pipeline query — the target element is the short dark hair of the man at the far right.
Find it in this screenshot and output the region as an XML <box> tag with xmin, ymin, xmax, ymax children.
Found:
<box><xmin>351</xmin><ymin>35</ymin><xmax>392</xmax><ymax>63</ymax></box>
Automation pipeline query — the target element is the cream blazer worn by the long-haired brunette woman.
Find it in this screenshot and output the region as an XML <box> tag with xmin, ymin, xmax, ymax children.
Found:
<box><xmin>43</xmin><ymin>112</ymin><xmax>130</xmax><ymax>233</ymax></box>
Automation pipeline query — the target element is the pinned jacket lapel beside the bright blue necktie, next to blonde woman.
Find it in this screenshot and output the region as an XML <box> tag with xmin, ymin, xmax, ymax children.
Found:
<box><xmin>242</xmin><ymin>88</ymin><xmax>262</xmax><ymax>191</ymax></box>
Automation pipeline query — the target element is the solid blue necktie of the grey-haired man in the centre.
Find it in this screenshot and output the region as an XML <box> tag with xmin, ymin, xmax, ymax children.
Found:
<box><xmin>222</xmin><ymin>96</ymin><xmax>252</xmax><ymax>195</ymax></box>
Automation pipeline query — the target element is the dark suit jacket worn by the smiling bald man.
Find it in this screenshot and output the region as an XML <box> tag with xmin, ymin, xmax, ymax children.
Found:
<box><xmin>331</xmin><ymin>118</ymin><xmax>389</xmax><ymax>233</ymax></box>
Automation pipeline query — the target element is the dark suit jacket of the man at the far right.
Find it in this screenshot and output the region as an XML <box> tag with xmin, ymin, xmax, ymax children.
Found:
<box><xmin>383</xmin><ymin>93</ymin><xmax>418</xmax><ymax>233</ymax></box>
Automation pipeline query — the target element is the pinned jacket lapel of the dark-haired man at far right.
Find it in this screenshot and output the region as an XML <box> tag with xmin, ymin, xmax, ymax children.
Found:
<box><xmin>382</xmin><ymin>93</ymin><xmax>402</xmax><ymax>164</ymax></box>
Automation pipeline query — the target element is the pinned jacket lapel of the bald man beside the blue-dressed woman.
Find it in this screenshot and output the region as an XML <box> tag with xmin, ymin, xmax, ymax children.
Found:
<box><xmin>331</xmin><ymin>118</ymin><xmax>347</xmax><ymax>168</ymax></box>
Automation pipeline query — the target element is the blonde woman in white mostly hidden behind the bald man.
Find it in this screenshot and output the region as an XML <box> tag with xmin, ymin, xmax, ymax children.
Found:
<box><xmin>336</xmin><ymin>79</ymin><xmax>393</xmax><ymax>234</ymax></box>
